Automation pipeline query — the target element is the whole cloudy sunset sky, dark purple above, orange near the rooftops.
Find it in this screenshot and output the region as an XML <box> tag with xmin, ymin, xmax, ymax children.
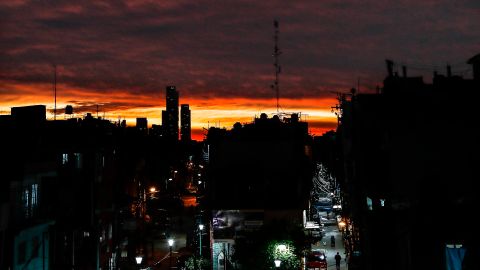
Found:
<box><xmin>0</xmin><ymin>0</ymin><xmax>480</xmax><ymax>139</ymax></box>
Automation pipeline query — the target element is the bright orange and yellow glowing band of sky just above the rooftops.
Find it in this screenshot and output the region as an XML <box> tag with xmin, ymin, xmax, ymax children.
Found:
<box><xmin>0</xmin><ymin>83</ymin><xmax>338</xmax><ymax>141</ymax></box>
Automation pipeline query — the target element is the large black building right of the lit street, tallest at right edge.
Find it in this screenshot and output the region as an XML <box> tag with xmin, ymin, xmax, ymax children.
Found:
<box><xmin>337</xmin><ymin>54</ymin><xmax>480</xmax><ymax>270</ymax></box>
